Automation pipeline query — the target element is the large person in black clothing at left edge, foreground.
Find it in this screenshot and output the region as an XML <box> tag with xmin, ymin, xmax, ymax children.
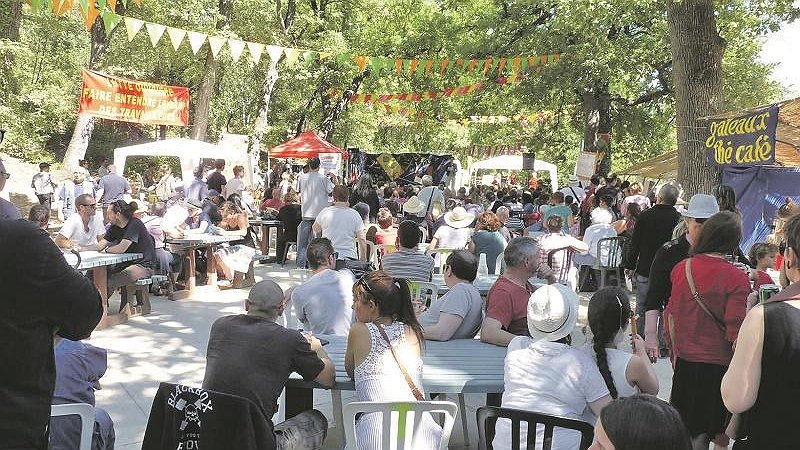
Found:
<box><xmin>0</xmin><ymin>220</ymin><xmax>103</xmax><ymax>449</ymax></box>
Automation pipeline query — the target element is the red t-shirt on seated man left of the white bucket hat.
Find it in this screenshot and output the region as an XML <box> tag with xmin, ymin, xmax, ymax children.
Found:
<box><xmin>486</xmin><ymin>276</ymin><xmax>536</xmax><ymax>336</ymax></box>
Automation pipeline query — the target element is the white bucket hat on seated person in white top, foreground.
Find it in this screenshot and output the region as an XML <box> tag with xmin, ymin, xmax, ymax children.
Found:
<box><xmin>528</xmin><ymin>284</ymin><xmax>579</xmax><ymax>342</ymax></box>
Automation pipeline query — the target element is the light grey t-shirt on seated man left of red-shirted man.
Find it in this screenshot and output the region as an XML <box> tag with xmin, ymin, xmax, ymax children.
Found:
<box><xmin>419</xmin><ymin>282</ymin><xmax>483</xmax><ymax>339</ymax></box>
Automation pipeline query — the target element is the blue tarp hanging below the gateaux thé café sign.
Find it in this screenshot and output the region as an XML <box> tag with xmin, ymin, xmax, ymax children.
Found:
<box><xmin>722</xmin><ymin>166</ymin><xmax>800</xmax><ymax>254</ymax></box>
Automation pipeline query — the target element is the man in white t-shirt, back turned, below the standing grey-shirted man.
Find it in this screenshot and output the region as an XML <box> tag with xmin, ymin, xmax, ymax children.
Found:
<box><xmin>312</xmin><ymin>185</ymin><xmax>367</xmax><ymax>260</ymax></box>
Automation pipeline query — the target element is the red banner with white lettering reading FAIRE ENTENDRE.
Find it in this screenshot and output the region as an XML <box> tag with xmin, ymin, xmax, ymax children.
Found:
<box><xmin>78</xmin><ymin>70</ymin><xmax>189</xmax><ymax>127</ymax></box>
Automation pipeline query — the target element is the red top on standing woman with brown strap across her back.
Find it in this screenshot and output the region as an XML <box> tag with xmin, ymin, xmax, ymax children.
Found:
<box><xmin>664</xmin><ymin>254</ymin><xmax>750</xmax><ymax>366</ymax></box>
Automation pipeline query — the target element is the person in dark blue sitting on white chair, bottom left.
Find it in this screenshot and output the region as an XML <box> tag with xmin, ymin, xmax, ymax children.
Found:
<box><xmin>50</xmin><ymin>338</ymin><xmax>115</xmax><ymax>450</ymax></box>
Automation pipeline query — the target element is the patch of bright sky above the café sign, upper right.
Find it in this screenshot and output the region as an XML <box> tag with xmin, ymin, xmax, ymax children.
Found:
<box><xmin>761</xmin><ymin>12</ymin><xmax>800</xmax><ymax>98</ymax></box>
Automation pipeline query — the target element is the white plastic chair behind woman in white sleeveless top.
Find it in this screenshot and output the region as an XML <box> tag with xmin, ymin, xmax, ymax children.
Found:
<box><xmin>344</xmin><ymin>401</ymin><xmax>458</xmax><ymax>450</ymax></box>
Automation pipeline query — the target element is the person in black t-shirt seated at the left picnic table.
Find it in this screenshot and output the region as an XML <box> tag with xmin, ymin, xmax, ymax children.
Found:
<box><xmin>97</xmin><ymin>200</ymin><xmax>156</xmax><ymax>306</ymax></box>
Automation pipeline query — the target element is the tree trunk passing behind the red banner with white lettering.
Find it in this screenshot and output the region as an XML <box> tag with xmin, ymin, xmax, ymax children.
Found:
<box><xmin>62</xmin><ymin>13</ymin><xmax>119</xmax><ymax>172</ymax></box>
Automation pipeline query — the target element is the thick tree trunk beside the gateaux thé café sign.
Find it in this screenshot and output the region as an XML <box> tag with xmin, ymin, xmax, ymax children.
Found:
<box><xmin>667</xmin><ymin>0</ymin><xmax>725</xmax><ymax>197</ymax></box>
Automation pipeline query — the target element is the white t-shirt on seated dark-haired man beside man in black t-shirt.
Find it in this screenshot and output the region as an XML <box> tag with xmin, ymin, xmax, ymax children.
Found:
<box><xmin>292</xmin><ymin>269</ymin><xmax>355</xmax><ymax>336</ymax></box>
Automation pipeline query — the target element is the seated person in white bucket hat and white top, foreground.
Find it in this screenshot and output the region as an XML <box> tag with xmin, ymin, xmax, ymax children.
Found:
<box><xmin>493</xmin><ymin>284</ymin><xmax>611</xmax><ymax>450</ymax></box>
